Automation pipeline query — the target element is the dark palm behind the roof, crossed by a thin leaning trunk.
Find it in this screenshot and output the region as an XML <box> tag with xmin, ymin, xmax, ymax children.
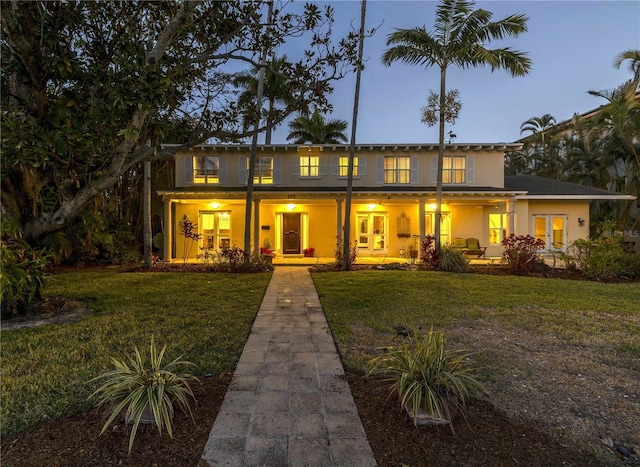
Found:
<box><xmin>233</xmin><ymin>55</ymin><xmax>293</xmax><ymax>144</ymax></box>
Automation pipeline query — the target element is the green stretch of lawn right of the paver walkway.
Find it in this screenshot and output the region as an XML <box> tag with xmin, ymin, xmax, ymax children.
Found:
<box><xmin>313</xmin><ymin>271</ymin><xmax>640</xmax><ymax>369</ymax></box>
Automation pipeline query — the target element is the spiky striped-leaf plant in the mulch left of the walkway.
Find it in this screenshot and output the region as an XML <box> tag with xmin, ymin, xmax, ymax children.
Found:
<box><xmin>89</xmin><ymin>337</ymin><xmax>197</xmax><ymax>452</ymax></box>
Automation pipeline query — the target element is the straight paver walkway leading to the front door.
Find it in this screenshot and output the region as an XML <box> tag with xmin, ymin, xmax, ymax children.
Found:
<box><xmin>202</xmin><ymin>266</ymin><xmax>376</xmax><ymax>467</ymax></box>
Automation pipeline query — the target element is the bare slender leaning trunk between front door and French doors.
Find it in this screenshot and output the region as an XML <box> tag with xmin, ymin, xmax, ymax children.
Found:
<box><xmin>342</xmin><ymin>0</ymin><xmax>367</xmax><ymax>271</ymax></box>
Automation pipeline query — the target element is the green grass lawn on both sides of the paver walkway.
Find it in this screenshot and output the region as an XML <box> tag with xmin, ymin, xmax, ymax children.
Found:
<box><xmin>0</xmin><ymin>271</ymin><xmax>640</xmax><ymax>440</ymax></box>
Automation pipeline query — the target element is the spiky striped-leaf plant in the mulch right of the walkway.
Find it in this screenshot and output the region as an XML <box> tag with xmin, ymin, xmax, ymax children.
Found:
<box><xmin>368</xmin><ymin>329</ymin><xmax>484</xmax><ymax>433</ymax></box>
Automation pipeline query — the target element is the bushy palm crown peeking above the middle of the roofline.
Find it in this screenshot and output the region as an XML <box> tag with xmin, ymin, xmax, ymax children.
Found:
<box><xmin>287</xmin><ymin>110</ymin><xmax>348</xmax><ymax>144</ymax></box>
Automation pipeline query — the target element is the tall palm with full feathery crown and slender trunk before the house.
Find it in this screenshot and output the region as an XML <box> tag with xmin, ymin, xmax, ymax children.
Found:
<box><xmin>382</xmin><ymin>0</ymin><xmax>531</xmax><ymax>253</ymax></box>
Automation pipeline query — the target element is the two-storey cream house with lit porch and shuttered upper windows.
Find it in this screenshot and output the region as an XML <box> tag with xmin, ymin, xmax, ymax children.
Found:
<box><xmin>159</xmin><ymin>143</ymin><xmax>629</xmax><ymax>260</ymax></box>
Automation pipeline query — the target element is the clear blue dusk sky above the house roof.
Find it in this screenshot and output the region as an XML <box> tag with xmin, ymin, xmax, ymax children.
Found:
<box><xmin>273</xmin><ymin>0</ymin><xmax>640</xmax><ymax>143</ymax></box>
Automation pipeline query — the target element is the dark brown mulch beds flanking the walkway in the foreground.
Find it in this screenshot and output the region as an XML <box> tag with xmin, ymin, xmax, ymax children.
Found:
<box><xmin>2</xmin><ymin>373</ymin><xmax>600</xmax><ymax>467</ymax></box>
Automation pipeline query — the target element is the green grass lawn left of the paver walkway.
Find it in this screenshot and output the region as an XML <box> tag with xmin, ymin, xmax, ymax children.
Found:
<box><xmin>0</xmin><ymin>272</ymin><xmax>271</xmax><ymax>433</ymax></box>
